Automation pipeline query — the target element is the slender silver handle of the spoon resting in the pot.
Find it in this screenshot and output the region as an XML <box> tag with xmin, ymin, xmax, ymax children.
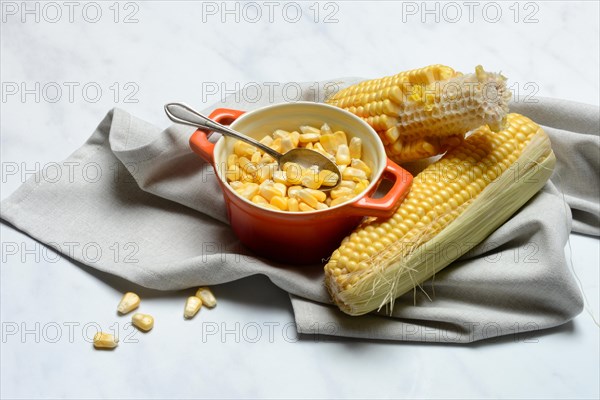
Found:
<box><xmin>165</xmin><ymin>103</ymin><xmax>281</xmax><ymax>160</ymax></box>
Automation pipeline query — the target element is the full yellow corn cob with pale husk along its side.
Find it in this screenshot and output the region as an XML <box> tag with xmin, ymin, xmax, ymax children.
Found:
<box><xmin>325</xmin><ymin>114</ymin><xmax>555</xmax><ymax>315</ymax></box>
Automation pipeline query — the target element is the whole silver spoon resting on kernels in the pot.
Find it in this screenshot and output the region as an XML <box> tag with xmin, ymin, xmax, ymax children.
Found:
<box><xmin>165</xmin><ymin>103</ymin><xmax>342</xmax><ymax>192</ymax></box>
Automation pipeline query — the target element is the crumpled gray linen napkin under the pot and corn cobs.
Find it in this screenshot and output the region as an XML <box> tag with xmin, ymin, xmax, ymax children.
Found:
<box><xmin>1</xmin><ymin>78</ymin><xmax>600</xmax><ymax>342</ymax></box>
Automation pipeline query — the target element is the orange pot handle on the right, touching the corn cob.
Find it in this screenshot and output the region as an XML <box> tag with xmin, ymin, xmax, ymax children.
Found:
<box><xmin>348</xmin><ymin>158</ymin><xmax>413</xmax><ymax>218</ymax></box>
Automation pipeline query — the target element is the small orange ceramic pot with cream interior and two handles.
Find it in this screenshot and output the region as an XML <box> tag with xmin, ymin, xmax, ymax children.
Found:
<box><xmin>190</xmin><ymin>102</ymin><xmax>412</xmax><ymax>264</ymax></box>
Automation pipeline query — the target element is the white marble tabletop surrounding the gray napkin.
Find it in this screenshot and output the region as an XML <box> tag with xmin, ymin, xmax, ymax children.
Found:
<box><xmin>0</xmin><ymin>1</ymin><xmax>600</xmax><ymax>398</ymax></box>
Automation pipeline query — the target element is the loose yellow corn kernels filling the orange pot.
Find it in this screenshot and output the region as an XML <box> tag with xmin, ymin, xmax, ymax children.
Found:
<box><xmin>225</xmin><ymin>123</ymin><xmax>371</xmax><ymax>212</ymax></box>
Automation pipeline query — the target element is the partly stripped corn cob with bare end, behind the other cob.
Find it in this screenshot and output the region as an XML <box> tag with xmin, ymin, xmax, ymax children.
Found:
<box><xmin>326</xmin><ymin>65</ymin><xmax>510</xmax><ymax>163</ymax></box>
